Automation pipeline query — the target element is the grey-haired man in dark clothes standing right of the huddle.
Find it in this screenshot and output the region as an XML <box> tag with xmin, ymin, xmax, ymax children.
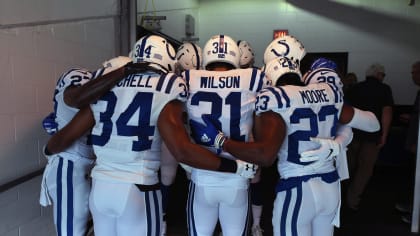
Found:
<box><xmin>346</xmin><ymin>64</ymin><xmax>394</xmax><ymax>210</ymax></box>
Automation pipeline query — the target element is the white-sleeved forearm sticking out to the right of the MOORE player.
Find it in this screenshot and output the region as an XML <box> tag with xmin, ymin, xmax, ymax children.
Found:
<box><xmin>339</xmin><ymin>104</ymin><xmax>381</xmax><ymax>132</ymax></box>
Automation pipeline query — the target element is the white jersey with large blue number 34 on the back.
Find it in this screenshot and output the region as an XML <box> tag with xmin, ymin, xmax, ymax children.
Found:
<box><xmin>91</xmin><ymin>72</ymin><xmax>188</xmax><ymax>185</ymax></box>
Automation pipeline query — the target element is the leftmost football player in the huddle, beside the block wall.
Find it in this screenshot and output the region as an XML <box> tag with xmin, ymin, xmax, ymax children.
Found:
<box><xmin>40</xmin><ymin>57</ymin><xmax>131</xmax><ymax>235</ymax></box>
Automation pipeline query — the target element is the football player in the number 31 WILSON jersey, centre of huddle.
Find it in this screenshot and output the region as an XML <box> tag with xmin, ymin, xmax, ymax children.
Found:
<box><xmin>184</xmin><ymin>35</ymin><xmax>270</xmax><ymax>236</ymax></box>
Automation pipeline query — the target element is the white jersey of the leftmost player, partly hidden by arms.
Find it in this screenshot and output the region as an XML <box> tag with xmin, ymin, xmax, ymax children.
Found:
<box><xmin>54</xmin><ymin>68</ymin><xmax>93</xmax><ymax>159</ymax></box>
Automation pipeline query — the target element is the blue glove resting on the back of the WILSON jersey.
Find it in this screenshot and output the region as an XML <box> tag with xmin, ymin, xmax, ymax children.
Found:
<box><xmin>190</xmin><ymin>115</ymin><xmax>227</xmax><ymax>150</ymax></box>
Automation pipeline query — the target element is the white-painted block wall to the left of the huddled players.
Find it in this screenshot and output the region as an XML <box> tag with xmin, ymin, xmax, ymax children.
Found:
<box><xmin>0</xmin><ymin>0</ymin><xmax>119</xmax><ymax>236</ymax></box>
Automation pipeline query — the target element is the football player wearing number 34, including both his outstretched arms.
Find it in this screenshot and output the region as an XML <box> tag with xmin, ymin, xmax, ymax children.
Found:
<box><xmin>45</xmin><ymin>35</ymin><xmax>255</xmax><ymax>236</ymax></box>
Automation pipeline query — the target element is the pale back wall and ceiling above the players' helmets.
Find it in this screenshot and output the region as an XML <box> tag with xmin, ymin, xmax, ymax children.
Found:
<box><xmin>149</xmin><ymin>0</ymin><xmax>420</xmax><ymax>104</ymax></box>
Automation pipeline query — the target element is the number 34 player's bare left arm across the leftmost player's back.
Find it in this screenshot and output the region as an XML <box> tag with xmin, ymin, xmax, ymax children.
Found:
<box><xmin>44</xmin><ymin>106</ymin><xmax>95</xmax><ymax>155</ymax></box>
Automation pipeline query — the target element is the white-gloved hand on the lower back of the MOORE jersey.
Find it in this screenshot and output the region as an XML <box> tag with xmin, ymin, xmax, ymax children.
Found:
<box><xmin>299</xmin><ymin>137</ymin><xmax>340</xmax><ymax>162</ymax></box>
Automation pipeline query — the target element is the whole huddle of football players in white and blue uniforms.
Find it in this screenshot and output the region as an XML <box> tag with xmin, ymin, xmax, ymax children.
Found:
<box><xmin>40</xmin><ymin>34</ymin><xmax>379</xmax><ymax>236</ymax></box>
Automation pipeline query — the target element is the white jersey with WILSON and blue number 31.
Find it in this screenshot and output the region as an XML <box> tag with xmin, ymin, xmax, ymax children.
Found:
<box><xmin>183</xmin><ymin>68</ymin><xmax>271</xmax><ymax>187</ymax></box>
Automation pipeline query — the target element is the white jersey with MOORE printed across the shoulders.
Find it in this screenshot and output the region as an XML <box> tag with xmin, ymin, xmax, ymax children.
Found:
<box><xmin>256</xmin><ymin>83</ymin><xmax>343</xmax><ymax>178</ymax></box>
